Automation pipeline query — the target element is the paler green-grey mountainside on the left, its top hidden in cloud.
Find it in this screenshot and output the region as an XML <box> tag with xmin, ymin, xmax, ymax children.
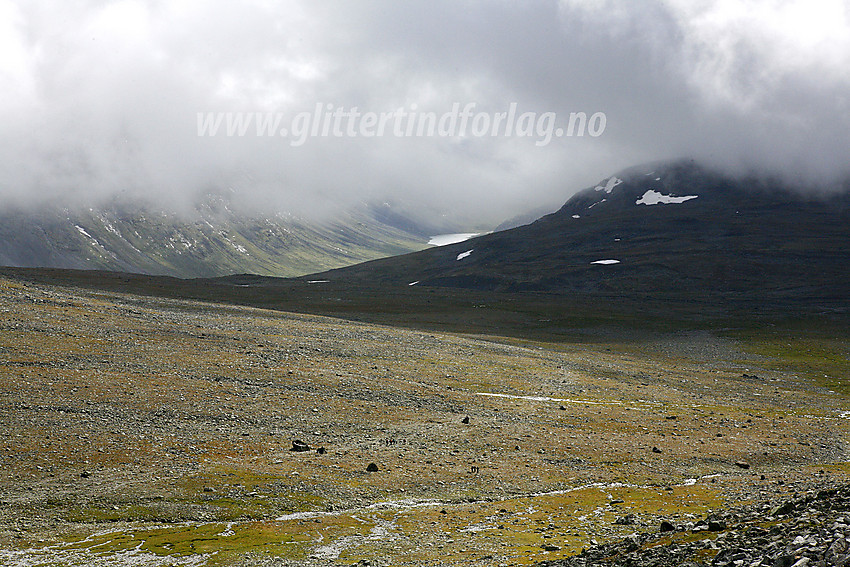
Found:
<box><xmin>0</xmin><ymin>194</ymin><xmax>438</xmax><ymax>278</ymax></box>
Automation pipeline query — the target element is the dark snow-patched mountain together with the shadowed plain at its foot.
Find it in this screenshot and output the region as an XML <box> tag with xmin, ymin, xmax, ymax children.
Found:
<box><xmin>0</xmin><ymin>162</ymin><xmax>850</xmax><ymax>332</ymax></box>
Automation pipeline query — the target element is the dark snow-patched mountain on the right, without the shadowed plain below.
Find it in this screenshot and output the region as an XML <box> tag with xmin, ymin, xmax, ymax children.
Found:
<box><xmin>310</xmin><ymin>161</ymin><xmax>850</xmax><ymax>311</ymax></box>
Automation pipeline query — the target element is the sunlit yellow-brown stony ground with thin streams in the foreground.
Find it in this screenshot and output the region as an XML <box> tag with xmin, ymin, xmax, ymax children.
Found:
<box><xmin>0</xmin><ymin>272</ymin><xmax>850</xmax><ymax>567</ymax></box>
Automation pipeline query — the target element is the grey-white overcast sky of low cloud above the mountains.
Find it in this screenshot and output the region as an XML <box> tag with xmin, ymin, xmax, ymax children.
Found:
<box><xmin>0</xmin><ymin>0</ymin><xmax>850</xmax><ymax>221</ymax></box>
